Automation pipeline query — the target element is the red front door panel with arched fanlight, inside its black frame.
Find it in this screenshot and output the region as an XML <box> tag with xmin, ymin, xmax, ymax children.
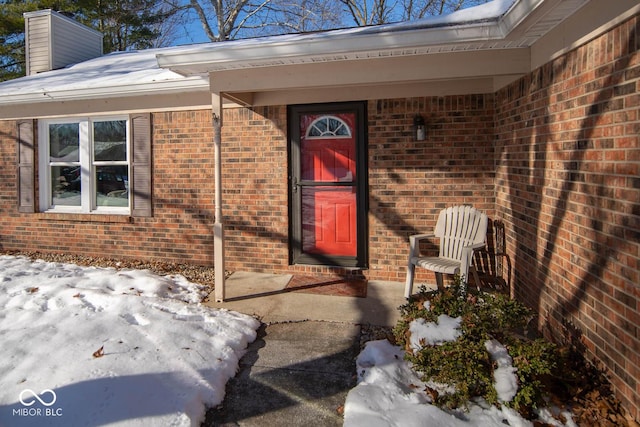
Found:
<box><xmin>300</xmin><ymin>113</ymin><xmax>357</xmax><ymax>256</ymax></box>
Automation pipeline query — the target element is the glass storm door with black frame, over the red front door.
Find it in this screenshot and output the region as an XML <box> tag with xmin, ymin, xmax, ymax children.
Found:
<box><xmin>290</xmin><ymin>104</ymin><xmax>366</xmax><ymax>266</ymax></box>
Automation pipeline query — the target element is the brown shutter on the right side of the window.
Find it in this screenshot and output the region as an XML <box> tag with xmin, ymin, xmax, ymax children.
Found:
<box><xmin>130</xmin><ymin>113</ymin><xmax>152</xmax><ymax>217</ymax></box>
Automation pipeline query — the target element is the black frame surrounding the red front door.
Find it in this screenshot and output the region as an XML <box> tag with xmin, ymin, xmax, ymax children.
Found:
<box><xmin>287</xmin><ymin>101</ymin><xmax>369</xmax><ymax>268</ymax></box>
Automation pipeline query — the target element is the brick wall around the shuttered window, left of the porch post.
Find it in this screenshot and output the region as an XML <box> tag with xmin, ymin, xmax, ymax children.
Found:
<box><xmin>0</xmin><ymin>111</ymin><xmax>218</xmax><ymax>264</ymax></box>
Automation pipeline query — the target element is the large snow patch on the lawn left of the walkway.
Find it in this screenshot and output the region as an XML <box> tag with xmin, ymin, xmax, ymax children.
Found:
<box><xmin>0</xmin><ymin>256</ymin><xmax>259</xmax><ymax>427</ymax></box>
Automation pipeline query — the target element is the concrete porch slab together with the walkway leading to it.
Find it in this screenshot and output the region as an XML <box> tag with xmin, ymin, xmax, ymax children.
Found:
<box><xmin>203</xmin><ymin>273</ymin><xmax>405</xmax><ymax>427</ymax></box>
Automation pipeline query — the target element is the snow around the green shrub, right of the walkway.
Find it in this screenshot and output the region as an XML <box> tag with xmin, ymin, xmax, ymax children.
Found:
<box><xmin>344</xmin><ymin>315</ymin><xmax>575</xmax><ymax>427</ymax></box>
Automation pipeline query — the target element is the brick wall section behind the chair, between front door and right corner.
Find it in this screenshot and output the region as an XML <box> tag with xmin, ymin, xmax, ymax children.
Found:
<box><xmin>368</xmin><ymin>95</ymin><xmax>494</xmax><ymax>284</ymax></box>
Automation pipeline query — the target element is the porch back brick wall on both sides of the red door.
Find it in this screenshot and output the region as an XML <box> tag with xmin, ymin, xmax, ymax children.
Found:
<box><xmin>222</xmin><ymin>95</ymin><xmax>494</xmax><ymax>282</ymax></box>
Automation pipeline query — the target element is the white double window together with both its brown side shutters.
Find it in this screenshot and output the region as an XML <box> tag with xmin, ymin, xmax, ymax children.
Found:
<box><xmin>16</xmin><ymin>113</ymin><xmax>153</xmax><ymax>217</ymax></box>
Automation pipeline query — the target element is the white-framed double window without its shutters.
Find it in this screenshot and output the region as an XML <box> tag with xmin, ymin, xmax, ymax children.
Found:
<box><xmin>39</xmin><ymin>116</ymin><xmax>131</xmax><ymax>214</ymax></box>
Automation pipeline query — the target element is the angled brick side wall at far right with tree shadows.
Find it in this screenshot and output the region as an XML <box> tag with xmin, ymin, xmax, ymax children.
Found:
<box><xmin>496</xmin><ymin>17</ymin><xmax>640</xmax><ymax>419</ymax></box>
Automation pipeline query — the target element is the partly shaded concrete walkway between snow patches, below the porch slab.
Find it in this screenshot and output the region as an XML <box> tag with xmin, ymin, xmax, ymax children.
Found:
<box><xmin>204</xmin><ymin>321</ymin><xmax>360</xmax><ymax>427</ymax></box>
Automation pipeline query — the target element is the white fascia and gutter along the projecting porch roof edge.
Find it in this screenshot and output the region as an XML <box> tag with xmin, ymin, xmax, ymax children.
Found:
<box><xmin>156</xmin><ymin>0</ymin><xmax>548</xmax><ymax>75</ymax></box>
